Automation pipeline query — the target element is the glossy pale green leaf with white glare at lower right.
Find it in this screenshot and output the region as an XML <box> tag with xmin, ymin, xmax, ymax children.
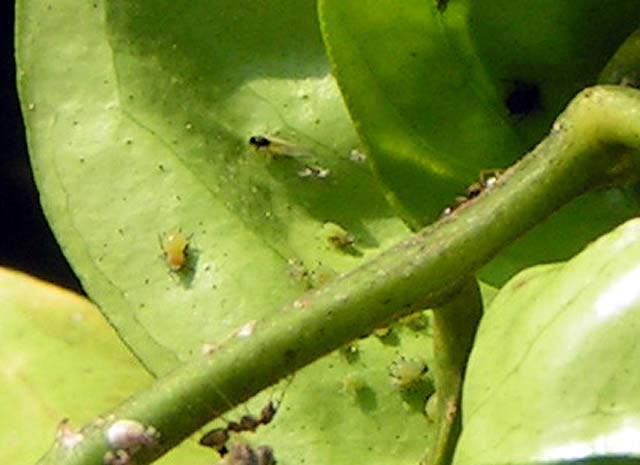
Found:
<box><xmin>454</xmin><ymin>220</ymin><xmax>640</xmax><ymax>465</ymax></box>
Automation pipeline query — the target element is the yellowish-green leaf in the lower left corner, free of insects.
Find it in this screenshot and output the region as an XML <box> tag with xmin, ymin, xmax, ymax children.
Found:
<box><xmin>0</xmin><ymin>269</ymin><xmax>211</xmax><ymax>465</ymax></box>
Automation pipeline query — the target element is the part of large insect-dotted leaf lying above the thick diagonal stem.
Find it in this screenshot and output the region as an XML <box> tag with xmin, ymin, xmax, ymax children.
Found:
<box><xmin>17</xmin><ymin>0</ymin><xmax>407</xmax><ymax>373</ymax></box>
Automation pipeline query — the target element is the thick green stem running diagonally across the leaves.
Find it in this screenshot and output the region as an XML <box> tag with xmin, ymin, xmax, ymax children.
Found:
<box><xmin>39</xmin><ymin>86</ymin><xmax>640</xmax><ymax>465</ymax></box>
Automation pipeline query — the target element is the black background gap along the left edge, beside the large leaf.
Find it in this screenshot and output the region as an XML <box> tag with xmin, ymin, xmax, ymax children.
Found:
<box><xmin>0</xmin><ymin>0</ymin><xmax>81</xmax><ymax>291</ymax></box>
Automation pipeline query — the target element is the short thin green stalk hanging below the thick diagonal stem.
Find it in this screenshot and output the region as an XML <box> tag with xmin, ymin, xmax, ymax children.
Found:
<box><xmin>423</xmin><ymin>278</ymin><xmax>482</xmax><ymax>465</ymax></box>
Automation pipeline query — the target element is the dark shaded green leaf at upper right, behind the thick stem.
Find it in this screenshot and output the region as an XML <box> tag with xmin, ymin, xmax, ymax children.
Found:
<box><xmin>320</xmin><ymin>0</ymin><xmax>639</xmax><ymax>285</ymax></box>
